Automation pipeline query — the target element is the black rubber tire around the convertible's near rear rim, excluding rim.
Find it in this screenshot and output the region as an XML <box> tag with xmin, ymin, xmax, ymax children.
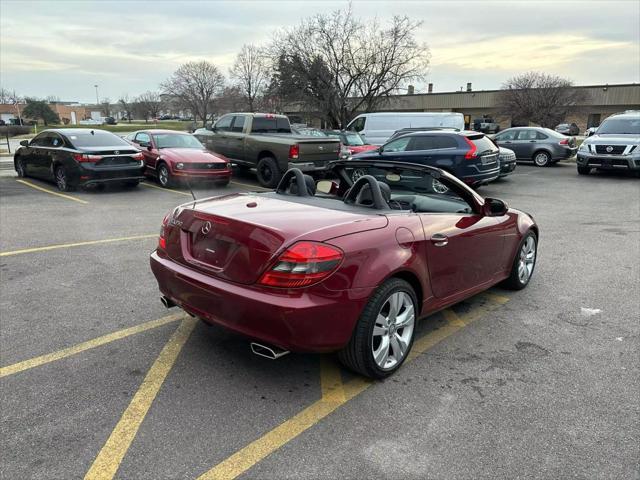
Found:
<box><xmin>338</xmin><ymin>278</ymin><xmax>419</xmax><ymax>379</ymax></box>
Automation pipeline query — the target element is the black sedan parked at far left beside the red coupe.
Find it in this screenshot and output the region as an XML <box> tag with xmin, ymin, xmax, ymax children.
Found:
<box><xmin>14</xmin><ymin>128</ymin><xmax>144</xmax><ymax>192</ymax></box>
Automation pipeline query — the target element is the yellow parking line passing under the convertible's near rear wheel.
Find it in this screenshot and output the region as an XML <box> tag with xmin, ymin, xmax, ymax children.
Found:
<box><xmin>198</xmin><ymin>297</ymin><xmax>508</xmax><ymax>480</ymax></box>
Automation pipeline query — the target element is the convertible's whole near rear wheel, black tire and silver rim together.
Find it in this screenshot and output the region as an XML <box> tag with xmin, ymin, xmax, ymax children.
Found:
<box><xmin>338</xmin><ymin>278</ymin><xmax>418</xmax><ymax>379</ymax></box>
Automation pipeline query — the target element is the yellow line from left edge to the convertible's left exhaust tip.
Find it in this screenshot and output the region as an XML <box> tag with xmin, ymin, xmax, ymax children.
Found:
<box><xmin>0</xmin><ymin>313</ymin><xmax>184</xmax><ymax>378</ymax></box>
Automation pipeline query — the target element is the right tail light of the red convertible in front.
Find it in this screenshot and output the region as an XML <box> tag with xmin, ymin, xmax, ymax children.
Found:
<box><xmin>258</xmin><ymin>242</ymin><xmax>344</xmax><ymax>288</ymax></box>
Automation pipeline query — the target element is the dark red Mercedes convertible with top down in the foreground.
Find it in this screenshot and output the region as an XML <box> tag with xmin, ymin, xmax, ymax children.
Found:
<box><xmin>151</xmin><ymin>160</ymin><xmax>538</xmax><ymax>378</ymax></box>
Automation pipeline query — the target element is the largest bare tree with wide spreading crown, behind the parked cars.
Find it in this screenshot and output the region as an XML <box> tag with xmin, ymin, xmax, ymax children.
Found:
<box><xmin>270</xmin><ymin>6</ymin><xmax>429</xmax><ymax>127</ymax></box>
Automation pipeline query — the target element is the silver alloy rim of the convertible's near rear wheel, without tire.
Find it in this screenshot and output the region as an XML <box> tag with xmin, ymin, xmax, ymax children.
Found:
<box><xmin>371</xmin><ymin>291</ymin><xmax>416</xmax><ymax>370</ymax></box>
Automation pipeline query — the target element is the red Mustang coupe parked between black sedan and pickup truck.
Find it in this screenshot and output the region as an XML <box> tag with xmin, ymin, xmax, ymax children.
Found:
<box><xmin>125</xmin><ymin>130</ymin><xmax>231</xmax><ymax>187</ymax></box>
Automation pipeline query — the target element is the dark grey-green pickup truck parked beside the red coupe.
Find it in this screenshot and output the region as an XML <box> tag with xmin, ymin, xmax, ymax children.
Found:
<box><xmin>194</xmin><ymin>113</ymin><xmax>340</xmax><ymax>188</ymax></box>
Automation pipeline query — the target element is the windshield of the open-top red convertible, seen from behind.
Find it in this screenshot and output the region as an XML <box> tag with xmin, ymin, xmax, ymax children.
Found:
<box><xmin>344</xmin><ymin>165</ymin><xmax>473</xmax><ymax>213</ymax></box>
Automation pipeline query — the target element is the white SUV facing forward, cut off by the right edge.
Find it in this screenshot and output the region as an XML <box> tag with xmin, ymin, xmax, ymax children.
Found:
<box><xmin>577</xmin><ymin>110</ymin><xmax>640</xmax><ymax>175</ymax></box>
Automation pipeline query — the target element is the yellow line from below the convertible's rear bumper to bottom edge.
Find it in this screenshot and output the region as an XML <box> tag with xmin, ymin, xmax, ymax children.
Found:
<box><xmin>84</xmin><ymin>317</ymin><xmax>197</xmax><ymax>480</ymax></box>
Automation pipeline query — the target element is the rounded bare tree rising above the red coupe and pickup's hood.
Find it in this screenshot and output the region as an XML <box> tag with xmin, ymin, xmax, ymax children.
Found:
<box><xmin>161</xmin><ymin>61</ymin><xmax>224</xmax><ymax>126</ymax></box>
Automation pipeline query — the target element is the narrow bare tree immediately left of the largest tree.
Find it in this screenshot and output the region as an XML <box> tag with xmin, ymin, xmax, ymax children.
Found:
<box><xmin>229</xmin><ymin>45</ymin><xmax>270</xmax><ymax>112</ymax></box>
